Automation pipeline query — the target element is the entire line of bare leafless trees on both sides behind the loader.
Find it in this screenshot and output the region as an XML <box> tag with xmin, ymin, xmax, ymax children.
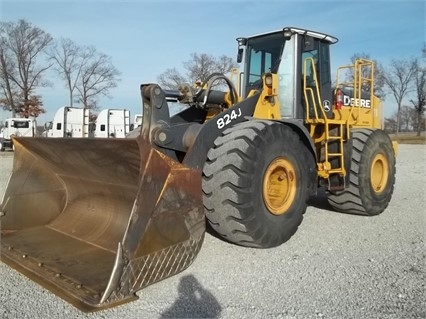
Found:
<box><xmin>0</xmin><ymin>20</ymin><xmax>426</xmax><ymax>135</ymax></box>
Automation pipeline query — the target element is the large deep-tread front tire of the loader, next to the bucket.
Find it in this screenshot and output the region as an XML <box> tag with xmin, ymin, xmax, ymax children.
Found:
<box><xmin>203</xmin><ymin>120</ymin><xmax>315</xmax><ymax>248</ymax></box>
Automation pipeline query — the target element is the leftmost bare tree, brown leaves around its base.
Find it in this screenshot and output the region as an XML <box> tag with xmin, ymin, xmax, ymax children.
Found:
<box><xmin>0</xmin><ymin>20</ymin><xmax>52</xmax><ymax>117</ymax></box>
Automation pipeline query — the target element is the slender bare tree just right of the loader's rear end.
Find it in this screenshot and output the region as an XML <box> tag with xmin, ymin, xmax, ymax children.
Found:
<box><xmin>384</xmin><ymin>60</ymin><xmax>415</xmax><ymax>135</ymax></box>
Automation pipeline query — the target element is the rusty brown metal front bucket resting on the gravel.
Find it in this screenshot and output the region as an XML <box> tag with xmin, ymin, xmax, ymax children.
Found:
<box><xmin>0</xmin><ymin>137</ymin><xmax>205</xmax><ymax>311</ymax></box>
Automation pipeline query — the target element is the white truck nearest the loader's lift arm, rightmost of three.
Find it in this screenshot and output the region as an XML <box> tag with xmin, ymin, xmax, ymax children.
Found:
<box><xmin>94</xmin><ymin>109</ymin><xmax>130</xmax><ymax>138</ymax></box>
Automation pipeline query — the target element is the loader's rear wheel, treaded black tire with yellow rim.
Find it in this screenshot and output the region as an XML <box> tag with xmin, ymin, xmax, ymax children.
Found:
<box><xmin>328</xmin><ymin>129</ymin><xmax>396</xmax><ymax>216</ymax></box>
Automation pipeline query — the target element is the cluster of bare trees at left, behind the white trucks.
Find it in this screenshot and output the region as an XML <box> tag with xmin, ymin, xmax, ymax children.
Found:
<box><xmin>0</xmin><ymin>20</ymin><xmax>120</xmax><ymax>117</ymax></box>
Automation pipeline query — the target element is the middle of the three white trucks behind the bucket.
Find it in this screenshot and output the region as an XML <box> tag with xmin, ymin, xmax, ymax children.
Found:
<box><xmin>45</xmin><ymin>106</ymin><xmax>90</xmax><ymax>137</ymax></box>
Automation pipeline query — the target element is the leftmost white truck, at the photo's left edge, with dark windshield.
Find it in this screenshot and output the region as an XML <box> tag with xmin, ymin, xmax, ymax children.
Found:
<box><xmin>0</xmin><ymin>117</ymin><xmax>37</xmax><ymax>152</ymax></box>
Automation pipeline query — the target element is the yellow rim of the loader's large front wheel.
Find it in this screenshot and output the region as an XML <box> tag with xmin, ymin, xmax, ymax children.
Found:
<box><xmin>263</xmin><ymin>157</ymin><xmax>297</xmax><ymax>215</ymax></box>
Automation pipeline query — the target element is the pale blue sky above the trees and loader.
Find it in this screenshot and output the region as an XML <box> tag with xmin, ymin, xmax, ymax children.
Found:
<box><xmin>0</xmin><ymin>0</ymin><xmax>426</xmax><ymax>124</ymax></box>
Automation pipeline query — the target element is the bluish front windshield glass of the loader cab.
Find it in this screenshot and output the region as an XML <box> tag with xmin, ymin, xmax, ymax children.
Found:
<box><xmin>246</xmin><ymin>32</ymin><xmax>285</xmax><ymax>87</ymax></box>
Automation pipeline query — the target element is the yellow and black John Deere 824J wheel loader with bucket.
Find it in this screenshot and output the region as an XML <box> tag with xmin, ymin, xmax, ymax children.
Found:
<box><xmin>0</xmin><ymin>27</ymin><xmax>397</xmax><ymax>311</ymax></box>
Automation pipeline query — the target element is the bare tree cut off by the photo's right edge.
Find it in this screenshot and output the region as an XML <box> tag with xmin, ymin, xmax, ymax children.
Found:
<box><xmin>410</xmin><ymin>57</ymin><xmax>426</xmax><ymax>136</ymax></box>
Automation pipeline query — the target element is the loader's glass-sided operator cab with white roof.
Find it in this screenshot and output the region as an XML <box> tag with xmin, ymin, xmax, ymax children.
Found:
<box><xmin>237</xmin><ymin>28</ymin><xmax>338</xmax><ymax>119</ymax></box>
